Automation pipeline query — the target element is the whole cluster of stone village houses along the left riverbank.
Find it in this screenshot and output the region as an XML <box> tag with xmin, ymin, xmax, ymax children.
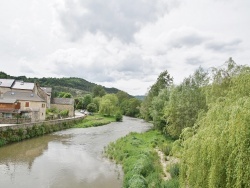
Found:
<box><xmin>0</xmin><ymin>79</ymin><xmax>74</xmax><ymax>123</ymax></box>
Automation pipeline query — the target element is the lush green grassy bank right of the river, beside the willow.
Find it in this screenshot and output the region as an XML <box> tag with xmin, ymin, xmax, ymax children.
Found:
<box><xmin>105</xmin><ymin>130</ymin><xmax>179</xmax><ymax>188</ymax></box>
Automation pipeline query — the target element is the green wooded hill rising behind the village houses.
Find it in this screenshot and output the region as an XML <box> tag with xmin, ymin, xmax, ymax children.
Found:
<box><xmin>0</xmin><ymin>72</ymin><xmax>120</xmax><ymax>96</ymax></box>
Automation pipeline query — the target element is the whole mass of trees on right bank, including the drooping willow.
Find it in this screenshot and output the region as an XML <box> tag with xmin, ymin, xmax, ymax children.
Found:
<box><xmin>140</xmin><ymin>58</ymin><xmax>250</xmax><ymax>188</ymax></box>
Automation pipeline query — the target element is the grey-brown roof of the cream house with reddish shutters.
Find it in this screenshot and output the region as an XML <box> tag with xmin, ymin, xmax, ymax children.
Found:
<box><xmin>3</xmin><ymin>91</ymin><xmax>44</xmax><ymax>102</ymax></box>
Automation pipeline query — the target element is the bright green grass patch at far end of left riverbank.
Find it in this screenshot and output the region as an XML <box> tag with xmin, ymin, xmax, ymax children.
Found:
<box><xmin>74</xmin><ymin>114</ymin><xmax>116</xmax><ymax>128</ymax></box>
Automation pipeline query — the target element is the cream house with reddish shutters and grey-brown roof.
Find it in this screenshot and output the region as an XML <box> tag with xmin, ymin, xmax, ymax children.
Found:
<box><xmin>1</xmin><ymin>91</ymin><xmax>46</xmax><ymax>122</ymax></box>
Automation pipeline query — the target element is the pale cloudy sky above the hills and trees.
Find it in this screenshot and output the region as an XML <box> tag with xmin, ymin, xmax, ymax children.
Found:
<box><xmin>0</xmin><ymin>0</ymin><xmax>250</xmax><ymax>95</ymax></box>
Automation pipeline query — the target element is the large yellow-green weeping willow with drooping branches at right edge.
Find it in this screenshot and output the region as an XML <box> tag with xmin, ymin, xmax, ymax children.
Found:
<box><xmin>180</xmin><ymin>67</ymin><xmax>250</xmax><ymax>188</ymax></box>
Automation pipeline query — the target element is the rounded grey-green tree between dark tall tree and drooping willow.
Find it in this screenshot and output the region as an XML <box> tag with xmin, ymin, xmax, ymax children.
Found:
<box><xmin>165</xmin><ymin>68</ymin><xmax>208</xmax><ymax>138</ymax></box>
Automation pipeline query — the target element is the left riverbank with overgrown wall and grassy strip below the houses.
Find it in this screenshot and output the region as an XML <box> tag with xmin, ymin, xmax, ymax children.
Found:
<box><xmin>0</xmin><ymin>114</ymin><xmax>119</xmax><ymax>147</ymax></box>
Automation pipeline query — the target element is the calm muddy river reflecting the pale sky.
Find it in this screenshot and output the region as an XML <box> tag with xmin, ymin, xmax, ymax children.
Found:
<box><xmin>0</xmin><ymin>117</ymin><xmax>151</xmax><ymax>188</ymax></box>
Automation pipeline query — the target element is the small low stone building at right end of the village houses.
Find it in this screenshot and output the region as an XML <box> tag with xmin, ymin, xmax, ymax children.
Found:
<box><xmin>51</xmin><ymin>98</ymin><xmax>75</xmax><ymax>117</ymax></box>
